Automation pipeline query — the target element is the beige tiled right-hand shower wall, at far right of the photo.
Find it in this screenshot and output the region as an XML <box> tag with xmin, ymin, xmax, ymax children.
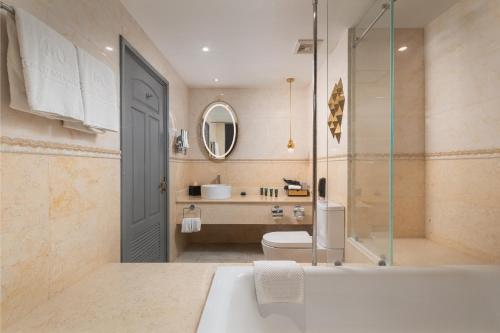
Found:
<box><xmin>425</xmin><ymin>0</ymin><xmax>500</xmax><ymax>263</ymax></box>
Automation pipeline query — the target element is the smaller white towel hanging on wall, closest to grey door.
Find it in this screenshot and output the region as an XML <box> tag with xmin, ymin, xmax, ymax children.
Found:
<box><xmin>72</xmin><ymin>47</ymin><xmax>120</xmax><ymax>132</ymax></box>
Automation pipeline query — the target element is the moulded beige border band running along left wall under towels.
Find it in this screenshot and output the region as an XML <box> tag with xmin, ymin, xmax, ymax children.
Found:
<box><xmin>0</xmin><ymin>136</ymin><xmax>121</xmax><ymax>159</ymax></box>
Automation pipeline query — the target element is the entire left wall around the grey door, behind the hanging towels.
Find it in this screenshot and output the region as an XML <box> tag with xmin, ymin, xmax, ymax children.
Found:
<box><xmin>0</xmin><ymin>0</ymin><xmax>188</xmax><ymax>328</ymax></box>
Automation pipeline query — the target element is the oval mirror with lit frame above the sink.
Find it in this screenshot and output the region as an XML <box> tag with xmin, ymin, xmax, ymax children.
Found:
<box><xmin>201</xmin><ymin>102</ymin><xmax>238</xmax><ymax>160</ymax></box>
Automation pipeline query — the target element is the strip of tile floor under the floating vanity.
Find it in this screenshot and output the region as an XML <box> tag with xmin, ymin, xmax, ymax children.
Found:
<box><xmin>175</xmin><ymin>243</ymin><xmax>264</xmax><ymax>263</ymax></box>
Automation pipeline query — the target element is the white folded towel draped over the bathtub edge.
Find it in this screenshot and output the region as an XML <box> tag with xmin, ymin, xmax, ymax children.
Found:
<box><xmin>254</xmin><ymin>260</ymin><xmax>304</xmax><ymax>304</ymax></box>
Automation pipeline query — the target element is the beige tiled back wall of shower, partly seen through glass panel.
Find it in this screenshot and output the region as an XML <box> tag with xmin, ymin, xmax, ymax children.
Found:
<box><xmin>350</xmin><ymin>28</ymin><xmax>425</xmax><ymax>244</ymax></box>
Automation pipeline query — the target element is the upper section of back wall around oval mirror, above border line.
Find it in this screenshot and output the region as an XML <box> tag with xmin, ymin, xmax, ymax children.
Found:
<box><xmin>188</xmin><ymin>87</ymin><xmax>312</xmax><ymax>160</ymax></box>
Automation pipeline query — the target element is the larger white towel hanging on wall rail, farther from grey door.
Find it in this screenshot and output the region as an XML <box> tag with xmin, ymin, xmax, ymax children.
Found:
<box><xmin>8</xmin><ymin>7</ymin><xmax>84</xmax><ymax>121</ymax></box>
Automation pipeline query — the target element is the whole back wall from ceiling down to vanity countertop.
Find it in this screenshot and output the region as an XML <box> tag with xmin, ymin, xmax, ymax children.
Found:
<box><xmin>187</xmin><ymin>87</ymin><xmax>312</xmax><ymax>187</ymax></box>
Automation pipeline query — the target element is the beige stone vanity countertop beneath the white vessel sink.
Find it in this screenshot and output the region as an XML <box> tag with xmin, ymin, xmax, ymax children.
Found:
<box><xmin>176</xmin><ymin>194</ymin><xmax>312</xmax><ymax>205</ymax></box>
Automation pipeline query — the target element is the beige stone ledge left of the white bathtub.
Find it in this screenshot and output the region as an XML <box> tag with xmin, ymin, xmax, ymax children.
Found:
<box><xmin>5</xmin><ymin>263</ymin><xmax>226</xmax><ymax>333</ymax></box>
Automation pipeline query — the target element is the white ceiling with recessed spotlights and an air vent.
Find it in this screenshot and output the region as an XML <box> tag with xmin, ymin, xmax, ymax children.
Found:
<box><xmin>121</xmin><ymin>0</ymin><xmax>457</xmax><ymax>88</ymax></box>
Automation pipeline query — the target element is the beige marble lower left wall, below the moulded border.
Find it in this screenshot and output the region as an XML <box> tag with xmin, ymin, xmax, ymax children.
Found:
<box><xmin>1</xmin><ymin>153</ymin><xmax>120</xmax><ymax>327</ymax></box>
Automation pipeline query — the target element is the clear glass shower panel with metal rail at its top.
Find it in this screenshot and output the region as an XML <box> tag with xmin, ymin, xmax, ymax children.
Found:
<box><xmin>348</xmin><ymin>0</ymin><xmax>393</xmax><ymax>264</ymax></box>
